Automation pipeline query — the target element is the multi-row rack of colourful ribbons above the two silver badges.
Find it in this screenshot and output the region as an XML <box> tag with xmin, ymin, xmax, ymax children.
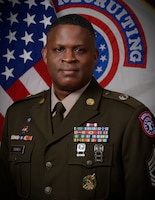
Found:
<box><xmin>73</xmin><ymin>123</ymin><xmax>109</xmax><ymax>143</ymax></box>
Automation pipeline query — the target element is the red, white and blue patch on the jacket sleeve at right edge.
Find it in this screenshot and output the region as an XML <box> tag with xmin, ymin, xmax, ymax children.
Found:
<box><xmin>138</xmin><ymin>111</ymin><xmax>155</xmax><ymax>137</ymax></box>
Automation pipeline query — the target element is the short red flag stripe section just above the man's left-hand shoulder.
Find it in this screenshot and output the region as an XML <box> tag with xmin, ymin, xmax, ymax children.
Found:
<box><xmin>6</xmin><ymin>80</ymin><xmax>30</xmax><ymax>101</ymax></box>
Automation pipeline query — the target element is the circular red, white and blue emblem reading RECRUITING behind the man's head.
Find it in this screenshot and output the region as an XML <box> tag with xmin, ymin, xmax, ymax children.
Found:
<box><xmin>53</xmin><ymin>0</ymin><xmax>147</xmax><ymax>87</ymax></box>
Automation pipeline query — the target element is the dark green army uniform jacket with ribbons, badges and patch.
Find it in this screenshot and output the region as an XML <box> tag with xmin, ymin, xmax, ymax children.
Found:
<box><xmin>0</xmin><ymin>79</ymin><xmax>155</xmax><ymax>200</ymax></box>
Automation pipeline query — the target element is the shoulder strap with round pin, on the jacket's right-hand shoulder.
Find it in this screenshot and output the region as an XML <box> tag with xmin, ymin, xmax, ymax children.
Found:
<box><xmin>103</xmin><ymin>90</ymin><xmax>144</xmax><ymax>108</ymax></box>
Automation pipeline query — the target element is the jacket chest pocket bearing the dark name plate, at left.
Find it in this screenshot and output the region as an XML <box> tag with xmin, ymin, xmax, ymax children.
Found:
<box><xmin>9</xmin><ymin>141</ymin><xmax>34</xmax><ymax>198</ymax></box>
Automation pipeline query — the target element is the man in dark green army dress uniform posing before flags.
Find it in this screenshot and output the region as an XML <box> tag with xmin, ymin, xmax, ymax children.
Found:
<box><xmin>1</xmin><ymin>14</ymin><xmax>155</xmax><ymax>200</ymax></box>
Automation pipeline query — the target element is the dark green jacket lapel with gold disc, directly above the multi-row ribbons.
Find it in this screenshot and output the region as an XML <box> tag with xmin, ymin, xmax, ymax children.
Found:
<box><xmin>48</xmin><ymin>79</ymin><xmax>103</xmax><ymax>144</ymax></box>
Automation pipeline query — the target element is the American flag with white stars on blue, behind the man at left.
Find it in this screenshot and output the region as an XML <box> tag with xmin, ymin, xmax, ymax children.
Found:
<box><xmin>0</xmin><ymin>0</ymin><xmax>56</xmax><ymax>139</ymax></box>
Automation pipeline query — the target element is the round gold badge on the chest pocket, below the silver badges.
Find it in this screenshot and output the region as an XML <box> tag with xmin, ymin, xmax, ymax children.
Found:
<box><xmin>82</xmin><ymin>173</ymin><xmax>96</xmax><ymax>190</ymax></box>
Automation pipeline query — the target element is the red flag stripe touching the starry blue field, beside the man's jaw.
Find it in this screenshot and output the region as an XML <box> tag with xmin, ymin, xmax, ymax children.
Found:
<box><xmin>34</xmin><ymin>59</ymin><xmax>52</xmax><ymax>86</ymax></box>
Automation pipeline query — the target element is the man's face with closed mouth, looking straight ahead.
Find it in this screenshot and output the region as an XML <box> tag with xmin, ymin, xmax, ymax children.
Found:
<box><xmin>42</xmin><ymin>25</ymin><xmax>98</xmax><ymax>91</ymax></box>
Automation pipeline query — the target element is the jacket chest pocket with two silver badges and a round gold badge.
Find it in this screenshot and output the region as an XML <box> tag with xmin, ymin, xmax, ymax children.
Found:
<box><xmin>68</xmin><ymin>143</ymin><xmax>113</xmax><ymax>200</ymax></box>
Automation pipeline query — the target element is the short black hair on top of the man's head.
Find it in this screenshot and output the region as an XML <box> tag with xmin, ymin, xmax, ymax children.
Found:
<box><xmin>48</xmin><ymin>14</ymin><xmax>95</xmax><ymax>37</ymax></box>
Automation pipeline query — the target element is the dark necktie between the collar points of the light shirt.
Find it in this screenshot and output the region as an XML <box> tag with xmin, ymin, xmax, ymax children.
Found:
<box><xmin>52</xmin><ymin>102</ymin><xmax>66</xmax><ymax>133</ymax></box>
